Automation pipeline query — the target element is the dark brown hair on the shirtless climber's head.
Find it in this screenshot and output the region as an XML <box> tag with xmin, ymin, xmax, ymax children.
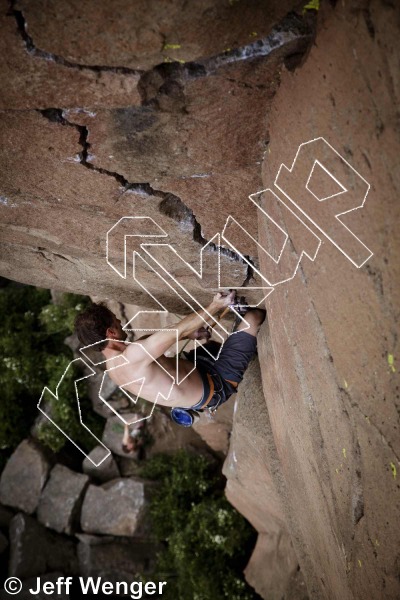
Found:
<box><xmin>75</xmin><ymin>302</ymin><xmax>115</xmax><ymax>351</ymax></box>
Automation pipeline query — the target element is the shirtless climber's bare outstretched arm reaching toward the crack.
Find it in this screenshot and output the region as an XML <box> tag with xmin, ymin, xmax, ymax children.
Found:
<box><xmin>126</xmin><ymin>292</ymin><xmax>235</xmax><ymax>364</ymax></box>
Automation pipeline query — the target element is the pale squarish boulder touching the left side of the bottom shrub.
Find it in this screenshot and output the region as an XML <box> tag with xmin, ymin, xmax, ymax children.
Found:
<box><xmin>81</xmin><ymin>478</ymin><xmax>152</xmax><ymax>536</ymax></box>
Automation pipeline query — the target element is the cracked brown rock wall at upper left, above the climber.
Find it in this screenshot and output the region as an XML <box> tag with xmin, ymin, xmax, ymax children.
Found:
<box><xmin>0</xmin><ymin>0</ymin><xmax>311</xmax><ymax>312</ymax></box>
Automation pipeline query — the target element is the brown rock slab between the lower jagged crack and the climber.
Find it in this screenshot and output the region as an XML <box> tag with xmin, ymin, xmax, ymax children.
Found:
<box><xmin>0</xmin><ymin>108</ymin><xmax>247</xmax><ymax>312</ymax></box>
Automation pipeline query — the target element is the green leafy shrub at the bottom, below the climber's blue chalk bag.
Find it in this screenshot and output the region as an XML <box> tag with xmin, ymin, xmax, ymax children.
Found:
<box><xmin>141</xmin><ymin>451</ymin><xmax>258</xmax><ymax>600</ymax></box>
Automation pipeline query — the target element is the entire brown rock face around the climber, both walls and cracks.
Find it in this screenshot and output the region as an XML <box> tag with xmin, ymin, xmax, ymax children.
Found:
<box><xmin>0</xmin><ymin>0</ymin><xmax>400</xmax><ymax>600</ymax></box>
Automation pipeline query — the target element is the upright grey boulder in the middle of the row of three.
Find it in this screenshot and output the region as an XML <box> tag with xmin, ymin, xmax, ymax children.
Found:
<box><xmin>37</xmin><ymin>465</ymin><xmax>89</xmax><ymax>534</ymax></box>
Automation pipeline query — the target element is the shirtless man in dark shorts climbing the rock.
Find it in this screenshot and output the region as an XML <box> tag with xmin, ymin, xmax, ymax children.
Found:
<box><xmin>75</xmin><ymin>291</ymin><xmax>265</xmax><ymax>425</ymax></box>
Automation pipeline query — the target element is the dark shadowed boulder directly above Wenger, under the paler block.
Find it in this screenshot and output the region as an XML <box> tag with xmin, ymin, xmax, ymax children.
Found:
<box><xmin>77</xmin><ymin>534</ymin><xmax>157</xmax><ymax>582</ymax></box>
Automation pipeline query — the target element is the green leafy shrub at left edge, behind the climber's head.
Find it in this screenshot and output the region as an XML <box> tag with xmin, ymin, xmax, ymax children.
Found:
<box><xmin>0</xmin><ymin>282</ymin><xmax>101</xmax><ymax>468</ymax></box>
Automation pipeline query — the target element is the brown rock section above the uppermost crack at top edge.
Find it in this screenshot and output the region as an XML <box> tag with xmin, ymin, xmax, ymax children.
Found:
<box><xmin>15</xmin><ymin>0</ymin><xmax>300</xmax><ymax>70</ymax></box>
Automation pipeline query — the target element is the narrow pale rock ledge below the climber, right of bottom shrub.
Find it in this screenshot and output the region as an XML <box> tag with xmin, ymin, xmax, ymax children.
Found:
<box><xmin>223</xmin><ymin>358</ymin><xmax>304</xmax><ymax>598</ymax></box>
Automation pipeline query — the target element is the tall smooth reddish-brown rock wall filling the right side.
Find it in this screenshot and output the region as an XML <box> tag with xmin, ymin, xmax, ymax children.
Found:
<box><xmin>259</xmin><ymin>2</ymin><xmax>400</xmax><ymax>599</ymax></box>
